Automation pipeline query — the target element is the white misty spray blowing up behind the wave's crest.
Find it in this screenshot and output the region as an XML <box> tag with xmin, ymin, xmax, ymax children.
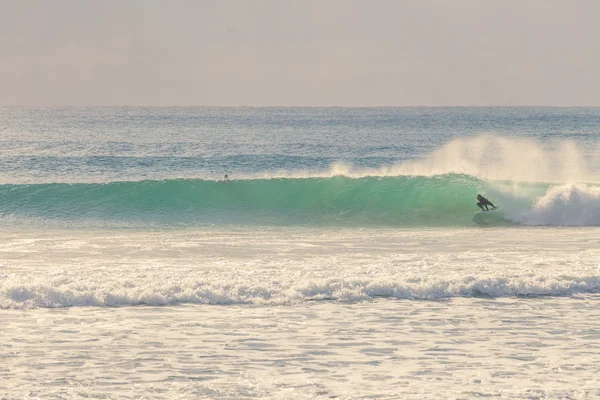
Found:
<box><xmin>310</xmin><ymin>134</ymin><xmax>600</xmax><ymax>183</ymax></box>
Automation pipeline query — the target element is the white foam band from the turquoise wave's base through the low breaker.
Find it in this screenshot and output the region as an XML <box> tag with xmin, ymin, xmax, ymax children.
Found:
<box><xmin>0</xmin><ymin>228</ymin><xmax>600</xmax><ymax>309</ymax></box>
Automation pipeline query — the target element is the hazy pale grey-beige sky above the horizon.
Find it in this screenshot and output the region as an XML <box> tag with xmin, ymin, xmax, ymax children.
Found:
<box><xmin>0</xmin><ymin>0</ymin><xmax>600</xmax><ymax>106</ymax></box>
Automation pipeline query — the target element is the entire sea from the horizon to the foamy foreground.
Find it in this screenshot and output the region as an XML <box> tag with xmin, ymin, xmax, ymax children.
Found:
<box><xmin>0</xmin><ymin>107</ymin><xmax>600</xmax><ymax>399</ymax></box>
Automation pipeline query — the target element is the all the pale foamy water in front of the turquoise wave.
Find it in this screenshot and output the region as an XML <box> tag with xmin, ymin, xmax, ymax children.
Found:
<box><xmin>0</xmin><ymin>228</ymin><xmax>600</xmax><ymax>400</ymax></box>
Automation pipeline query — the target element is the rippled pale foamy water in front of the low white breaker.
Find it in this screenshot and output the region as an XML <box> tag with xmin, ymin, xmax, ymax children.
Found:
<box><xmin>0</xmin><ymin>295</ymin><xmax>600</xmax><ymax>399</ymax></box>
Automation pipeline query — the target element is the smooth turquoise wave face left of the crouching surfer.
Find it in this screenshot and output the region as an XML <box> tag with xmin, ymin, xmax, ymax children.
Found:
<box><xmin>0</xmin><ymin>175</ymin><xmax>510</xmax><ymax>226</ymax></box>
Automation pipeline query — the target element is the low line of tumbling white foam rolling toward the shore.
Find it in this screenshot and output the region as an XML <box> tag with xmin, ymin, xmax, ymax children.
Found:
<box><xmin>0</xmin><ymin>275</ymin><xmax>600</xmax><ymax>309</ymax></box>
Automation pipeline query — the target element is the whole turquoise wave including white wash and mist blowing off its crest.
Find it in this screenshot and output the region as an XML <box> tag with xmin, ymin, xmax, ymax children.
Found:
<box><xmin>0</xmin><ymin>135</ymin><xmax>600</xmax><ymax>227</ymax></box>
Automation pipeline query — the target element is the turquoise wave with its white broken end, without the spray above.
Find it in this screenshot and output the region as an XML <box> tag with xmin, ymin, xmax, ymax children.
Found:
<box><xmin>0</xmin><ymin>174</ymin><xmax>600</xmax><ymax>227</ymax></box>
